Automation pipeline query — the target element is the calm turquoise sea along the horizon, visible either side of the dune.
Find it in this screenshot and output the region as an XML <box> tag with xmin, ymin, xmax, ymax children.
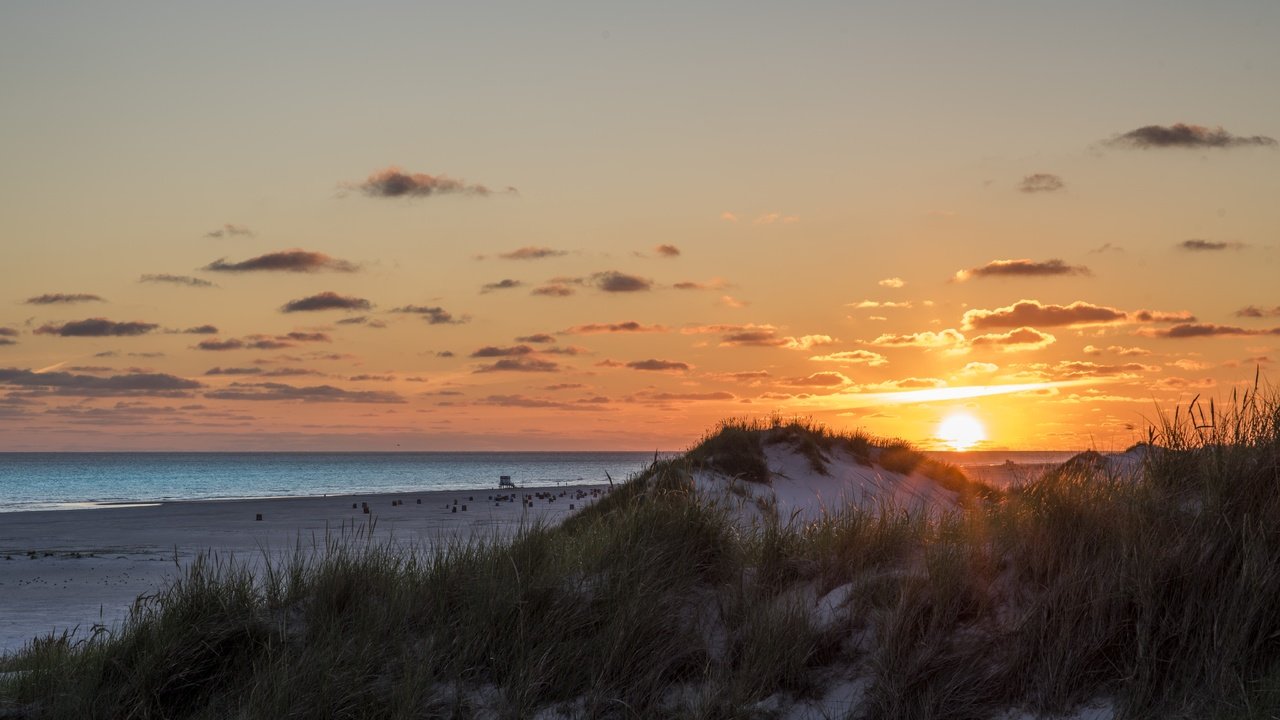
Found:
<box><xmin>0</xmin><ymin>450</ymin><xmax>1074</xmax><ymax>512</ymax></box>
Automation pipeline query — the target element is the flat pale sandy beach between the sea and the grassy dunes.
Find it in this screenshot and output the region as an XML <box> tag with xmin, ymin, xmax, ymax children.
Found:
<box><xmin>0</xmin><ymin>486</ymin><xmax>608</xmax><ymax>652</ymax></box>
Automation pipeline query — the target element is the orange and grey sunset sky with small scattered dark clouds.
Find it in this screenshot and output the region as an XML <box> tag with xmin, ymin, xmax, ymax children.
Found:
<box><xmin>0</xmin><ymin>0</ymin><xmax>1280</xmax><ymax>451</ymax></box>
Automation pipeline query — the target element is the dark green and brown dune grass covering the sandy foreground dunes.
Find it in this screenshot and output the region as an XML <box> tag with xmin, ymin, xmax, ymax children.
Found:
<box><xmin>0</xmin><ymin>393</ymin><xmax>1280</xmax><ymax>720</ymax></box>
